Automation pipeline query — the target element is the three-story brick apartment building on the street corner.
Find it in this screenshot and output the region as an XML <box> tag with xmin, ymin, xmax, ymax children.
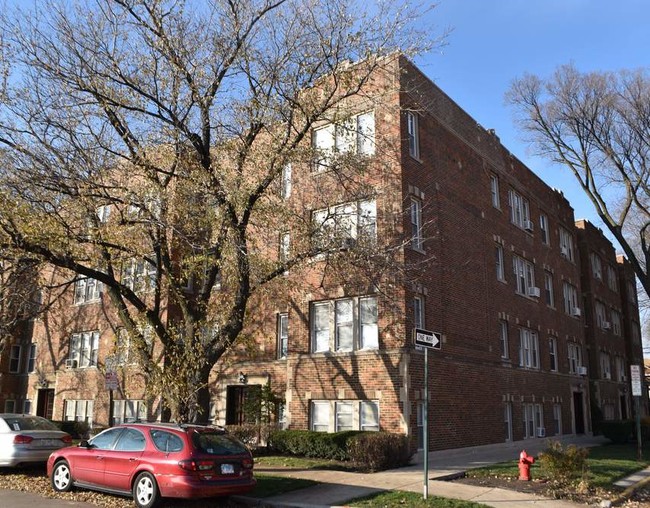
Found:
<box><xmin>0</xmin><ymin>57</ymin><xmax>647</xmax><ymax>449</ymax></box>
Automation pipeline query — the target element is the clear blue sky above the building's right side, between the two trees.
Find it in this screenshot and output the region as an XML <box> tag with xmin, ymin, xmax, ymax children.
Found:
<box><xmin>416</xmin><ymin>0</ymin><xmax>650</xmax><ymax>236</ymax></box>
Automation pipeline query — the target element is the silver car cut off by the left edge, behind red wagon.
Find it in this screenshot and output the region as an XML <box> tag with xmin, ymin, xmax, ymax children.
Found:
<box><xmin>0</xmin><ymin>413</ymin><xmax>72</xmax><ymax>467</ymax></box>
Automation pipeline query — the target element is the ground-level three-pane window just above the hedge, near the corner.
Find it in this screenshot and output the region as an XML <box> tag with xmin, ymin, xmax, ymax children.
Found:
<box><xmin>310</xmin><ymin>400</ymin><xmax>379</xmax><ymax>432</ymax></box>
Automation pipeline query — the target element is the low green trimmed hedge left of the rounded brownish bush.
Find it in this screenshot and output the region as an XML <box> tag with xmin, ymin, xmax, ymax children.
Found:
<box><xmin>268</xmin><ymin>430</ymin><xmax>360</xmax><ymax>460</ymax></box>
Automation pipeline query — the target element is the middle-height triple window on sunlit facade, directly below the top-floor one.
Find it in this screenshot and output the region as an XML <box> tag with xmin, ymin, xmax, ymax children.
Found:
<box><xmin>312</xmin><ymin>199</ymin><xmax>377</xmax><ymax>250</ymax></box>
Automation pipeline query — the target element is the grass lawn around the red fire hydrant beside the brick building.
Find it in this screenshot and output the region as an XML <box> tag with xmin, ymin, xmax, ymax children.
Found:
<box><xmin>467</xmin><ymin>444</ymin><xmax>650</xmax><ymax>489</ymax></box>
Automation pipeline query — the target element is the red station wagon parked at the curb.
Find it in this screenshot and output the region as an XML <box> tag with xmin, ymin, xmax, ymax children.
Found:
<box><xmin>47</xmin><ymin>423</ymin><xmax>255</xmax><ymax>508</ymax></box>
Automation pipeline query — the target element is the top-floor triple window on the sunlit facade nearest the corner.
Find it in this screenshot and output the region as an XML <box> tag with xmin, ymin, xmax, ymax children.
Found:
<box><xmin>312</xmin><ymin>111</ymin><xmax>375</xmax><ymax>171</ymax></box>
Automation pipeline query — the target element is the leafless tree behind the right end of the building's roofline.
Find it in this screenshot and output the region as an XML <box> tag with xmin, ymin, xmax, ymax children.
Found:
<box><xmin>507</xmin><ymin>65</ymin><xmax>650</xmax><ymax>295</ymax></box>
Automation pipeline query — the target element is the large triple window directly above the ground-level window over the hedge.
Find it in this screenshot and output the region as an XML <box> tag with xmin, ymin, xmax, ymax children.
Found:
<box><xmin>311</xmin><ymin>296</ymin><xmax>379</xmax><ymax>353</ymax></box>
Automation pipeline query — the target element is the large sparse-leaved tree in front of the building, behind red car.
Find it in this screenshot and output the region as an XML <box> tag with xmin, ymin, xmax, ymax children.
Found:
<box><xmin>0</xmin><ymin>0</ymin><xmax>435</xmax><ymax>420</ymax></box>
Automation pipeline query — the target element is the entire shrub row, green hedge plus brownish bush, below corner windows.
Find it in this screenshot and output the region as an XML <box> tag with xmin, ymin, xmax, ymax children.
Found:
<box><xmin>269</xmin><ymin>430</ymin><xmax>411</xmax><ymax>471</ymax></box>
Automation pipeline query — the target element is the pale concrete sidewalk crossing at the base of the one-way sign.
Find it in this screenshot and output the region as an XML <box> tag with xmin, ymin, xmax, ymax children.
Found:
<box><xmin>232</xmin><ymin>436</ymin><xmax>628</xmax><ymax>508</ymax></box>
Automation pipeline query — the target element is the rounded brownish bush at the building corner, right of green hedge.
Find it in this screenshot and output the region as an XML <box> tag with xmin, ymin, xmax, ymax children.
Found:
<box><xmin>348</xmin><ymin>432</ymin><xmax>412</xmax><ymax>471</ymax></box>
